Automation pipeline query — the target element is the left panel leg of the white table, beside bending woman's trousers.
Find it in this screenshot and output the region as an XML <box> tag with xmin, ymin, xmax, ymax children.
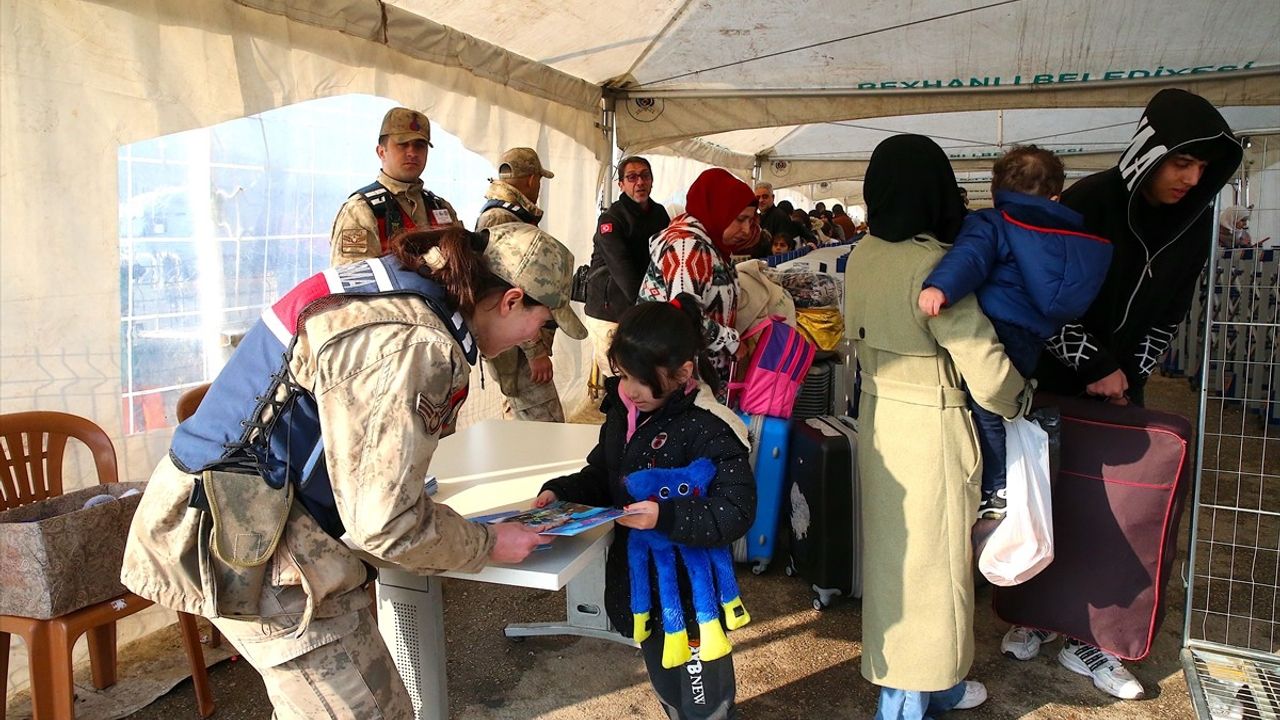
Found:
<box><xmin>378</xmin><ymin>568</ymin><xmax>449</xmax><ymax>720</ymax></box>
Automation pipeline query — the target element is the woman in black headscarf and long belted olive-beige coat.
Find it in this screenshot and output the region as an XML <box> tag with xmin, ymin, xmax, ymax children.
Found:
<box><xmin>845</xmin><ymin>135</ymin><xmax>1029</xmax><ymax>720</ymax></box>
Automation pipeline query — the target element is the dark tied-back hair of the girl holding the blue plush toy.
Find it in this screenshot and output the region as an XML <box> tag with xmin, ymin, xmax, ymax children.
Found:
<box><xmin>608</xmin><ymin>292</ymin><xmax>719</xmax><ymax>395</ymax></box>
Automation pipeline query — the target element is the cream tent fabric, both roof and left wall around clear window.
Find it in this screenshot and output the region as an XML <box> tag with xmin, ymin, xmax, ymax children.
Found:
<box><xmin>0</xmin><ymin>0</ymin><xmax>1280</xmax><ymax>689</ymax></box>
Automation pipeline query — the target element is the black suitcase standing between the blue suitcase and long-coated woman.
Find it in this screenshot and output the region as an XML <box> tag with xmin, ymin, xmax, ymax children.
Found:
<box><xmin>787</xmin><ymin>415</ymin><xmax>863</xmax><ymax>610</ymax></box>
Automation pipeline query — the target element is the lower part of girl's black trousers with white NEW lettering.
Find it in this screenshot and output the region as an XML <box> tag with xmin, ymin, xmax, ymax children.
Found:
<box><xmin>640</xmin><ymin>626</ymin><xmax>737</xmax><ymax>720</ymax></box>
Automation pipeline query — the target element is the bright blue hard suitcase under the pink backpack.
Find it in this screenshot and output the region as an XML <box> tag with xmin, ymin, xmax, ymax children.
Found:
<box><xmin>733</xmin><ymin>413</ymin><xmax>791</xmax><ymax>575</ymax></box>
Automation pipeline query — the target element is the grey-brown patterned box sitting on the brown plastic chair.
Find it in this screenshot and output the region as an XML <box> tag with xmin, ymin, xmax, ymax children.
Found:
<box><xmin>0</xmin><ymin>483</ymin><xmax>146</xmax><ymax>619</ymax></box>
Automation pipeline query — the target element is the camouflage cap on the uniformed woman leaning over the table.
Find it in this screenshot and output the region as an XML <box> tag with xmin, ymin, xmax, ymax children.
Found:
<box><xmin>484</xmin><ymin>223</ymin><xmax>586</xmax><ymax>340</ymax></box>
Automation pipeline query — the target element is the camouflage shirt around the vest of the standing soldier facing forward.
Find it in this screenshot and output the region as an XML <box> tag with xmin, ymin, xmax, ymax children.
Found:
<box><xmin>329</xmin><ymin>172</ymin><xmax>462</xmax><ymax>265</ymax></box>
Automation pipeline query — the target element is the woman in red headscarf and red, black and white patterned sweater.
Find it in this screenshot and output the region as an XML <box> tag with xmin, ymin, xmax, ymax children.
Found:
<box><xmin>640</xmin><ymin>168</ymin><xmax>760</xmax><ymax>400</ymax></box>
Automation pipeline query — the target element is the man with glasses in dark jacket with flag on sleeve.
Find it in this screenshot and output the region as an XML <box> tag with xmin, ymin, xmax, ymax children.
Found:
<box><xmin>584</xmin><ymin>155</ymin><xmax>671</xmax><ymax>375</ymax></box>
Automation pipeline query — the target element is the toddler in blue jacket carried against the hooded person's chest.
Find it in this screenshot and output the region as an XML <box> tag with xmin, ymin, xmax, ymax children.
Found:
<box><xmin>919</xmin><ymin>145</ymin><xmax>1111</xmax><ymax>518</ymax></box>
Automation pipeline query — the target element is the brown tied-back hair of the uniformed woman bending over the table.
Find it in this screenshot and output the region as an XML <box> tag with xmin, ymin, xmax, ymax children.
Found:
<box><xmin>390</xmin><ymin>225</ymin><xmax>512</xmax><ymax>314</ymax></box>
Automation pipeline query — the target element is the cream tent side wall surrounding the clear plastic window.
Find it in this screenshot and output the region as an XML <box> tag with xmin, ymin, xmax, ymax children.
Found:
<box><xmin>0</xmin><ymin>0</ymin><xmax>609</xmax><ymax>692</ymax></box>
